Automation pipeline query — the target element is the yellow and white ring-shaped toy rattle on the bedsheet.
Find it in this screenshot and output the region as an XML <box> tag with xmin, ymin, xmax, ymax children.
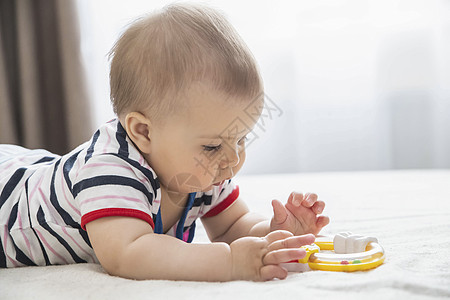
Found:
<box><xmin>282</xmin><ymin>232</ymin><xmax>385</xmax><ymax>272</ymax></box>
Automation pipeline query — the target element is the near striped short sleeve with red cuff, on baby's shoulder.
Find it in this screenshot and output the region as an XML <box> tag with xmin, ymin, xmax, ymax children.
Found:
<box><xmin>72</xmin><ymin>154</ymin><xmax>156</xmax><ymax>229</ymax></box>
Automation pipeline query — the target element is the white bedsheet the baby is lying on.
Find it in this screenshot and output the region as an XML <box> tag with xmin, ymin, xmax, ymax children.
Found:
<box><xmin>0</xmin><ymin>170</ymin><xmax>450</xmax><ymax>300</ymax></box>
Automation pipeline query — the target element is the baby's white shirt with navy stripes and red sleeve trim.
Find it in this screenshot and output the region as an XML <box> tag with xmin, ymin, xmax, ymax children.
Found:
<box><xmin>0</xmin><ymin>119</ymin><xmax>239</xmax><ymax>267</ymax></box>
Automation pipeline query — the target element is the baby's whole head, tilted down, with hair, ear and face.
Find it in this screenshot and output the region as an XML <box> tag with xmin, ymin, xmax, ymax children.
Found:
<box><xmin>110</xmin><ymin>4</ymin><xmax>263</xmax><ymax>192</ymax></box>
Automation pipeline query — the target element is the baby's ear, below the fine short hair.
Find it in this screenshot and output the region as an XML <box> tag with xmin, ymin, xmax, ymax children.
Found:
<box><xmin>123</xmin><ymin>112</ymin><xmax>152</xmax><ymax>154</ymax></box>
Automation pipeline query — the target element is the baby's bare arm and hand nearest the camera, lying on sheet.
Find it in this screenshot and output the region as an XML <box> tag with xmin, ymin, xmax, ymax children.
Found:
<box><xmin>86</xmin><ymin>217</ymin><xmax>314</xmax><ymax>281</ymax></box>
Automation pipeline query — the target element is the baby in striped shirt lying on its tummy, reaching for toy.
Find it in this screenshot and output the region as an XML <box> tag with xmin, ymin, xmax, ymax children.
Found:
<box><xmin>0</xmin><ymin>4</ymin><xmax>329</xmax><ymax>281</ymax></box>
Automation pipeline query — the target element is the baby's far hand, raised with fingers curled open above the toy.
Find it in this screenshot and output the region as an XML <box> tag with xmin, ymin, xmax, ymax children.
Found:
<box><xmin>270</xmin><ymin>192</ymin><xmax>330</xmax><ymax>235</ymax></box>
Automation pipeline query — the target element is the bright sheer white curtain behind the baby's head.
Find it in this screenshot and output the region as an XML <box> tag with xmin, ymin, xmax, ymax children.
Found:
<box><xmin>80</xmin><ymin>0</ymin><xmax>450</xmax><ymax>174</ymax></box>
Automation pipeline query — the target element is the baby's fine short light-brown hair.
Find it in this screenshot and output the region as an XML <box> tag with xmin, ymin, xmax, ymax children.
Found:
<box><xmin>110</xmin><ymin>4</ymin><xmax>263</xmax><ymax>119</ymax></box>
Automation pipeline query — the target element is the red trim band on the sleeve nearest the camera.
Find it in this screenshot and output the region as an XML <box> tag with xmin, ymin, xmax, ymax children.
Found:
<box><xmin>81</xmin><ymin>208</ymin><xmax>155</xmax><ymax>230</ymax></box>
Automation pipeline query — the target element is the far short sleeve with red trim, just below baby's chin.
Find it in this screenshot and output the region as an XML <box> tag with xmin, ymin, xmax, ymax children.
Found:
<box><xmin>202</xmin><ymin>179</ymin><xmax>239</xmax><ymax>218</ymax></box>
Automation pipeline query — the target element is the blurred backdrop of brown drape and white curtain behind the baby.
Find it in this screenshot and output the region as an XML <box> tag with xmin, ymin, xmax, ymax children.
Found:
<box><xmin>0</xmin><ymin>0</ymin><xmax>450</xmax><ymax>174</ymax></box>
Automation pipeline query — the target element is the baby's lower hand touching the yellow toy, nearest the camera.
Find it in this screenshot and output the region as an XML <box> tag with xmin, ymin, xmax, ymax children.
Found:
<box><xmin>230</xmin><ymin>230</ymin><xmax>315</xmax><ymax>281</ymax></box>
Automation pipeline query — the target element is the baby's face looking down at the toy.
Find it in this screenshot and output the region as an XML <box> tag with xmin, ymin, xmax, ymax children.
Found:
<box><xmin>146</xmin><ymin>84</ymin><xmax>263</xmax><ymax>193</ymax></box>
